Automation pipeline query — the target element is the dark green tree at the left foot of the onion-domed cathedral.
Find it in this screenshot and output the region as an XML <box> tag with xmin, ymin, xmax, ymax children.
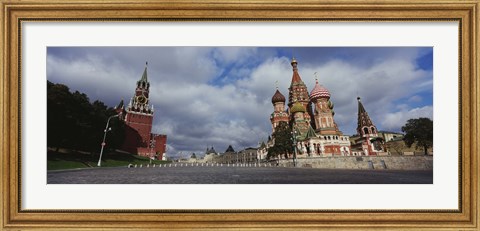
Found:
<box><xmin>267</xmin><ymin>121</ymin><xmax>293</xmax><ymax>159</ymax></box>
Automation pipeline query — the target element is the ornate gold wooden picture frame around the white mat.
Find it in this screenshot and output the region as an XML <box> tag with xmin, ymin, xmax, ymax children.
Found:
<box><xmin>0</xmin><ymin>0</ymin><xmax>480</xmax><ymax>230</ymax></box>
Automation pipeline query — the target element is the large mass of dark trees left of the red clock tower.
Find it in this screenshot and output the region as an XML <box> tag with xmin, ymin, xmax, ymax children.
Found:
<box><xmin>47</xmin><ymin>81</ymin><xmax>125</xmax><ymax>152</ymax></box>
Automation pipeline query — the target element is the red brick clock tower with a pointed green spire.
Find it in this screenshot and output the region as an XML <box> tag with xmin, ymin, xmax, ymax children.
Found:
<box><xmin>116</xmin><ymin>62</ymin><xmax>167</xmax><ymax>160</ymax></box>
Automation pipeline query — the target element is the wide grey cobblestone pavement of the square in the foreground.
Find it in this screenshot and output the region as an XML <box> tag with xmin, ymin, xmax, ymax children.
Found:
<box><xmin>47</xmin><ymin>163</ymin><xmax>433</xmax><ymax>184</ymax></box>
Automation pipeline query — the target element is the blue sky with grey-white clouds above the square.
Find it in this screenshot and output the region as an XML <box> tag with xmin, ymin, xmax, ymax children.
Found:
<box><xmin>47</xmin><ymin>47</ymin><xmax>433</xmax><ymax>157</ymax></box>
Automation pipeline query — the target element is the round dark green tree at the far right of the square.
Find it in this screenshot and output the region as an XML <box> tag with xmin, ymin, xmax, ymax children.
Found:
<box><xmin>402</xmin><ymin>118</ymin><xmax>433</xmax><ymax>155</ymax></box>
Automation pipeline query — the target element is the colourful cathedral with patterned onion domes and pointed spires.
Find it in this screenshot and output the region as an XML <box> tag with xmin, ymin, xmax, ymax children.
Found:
<box><xmin>268</xmin><ymin>58</ymin><xmax>387</xmax><ymax>157</ymax></box>
